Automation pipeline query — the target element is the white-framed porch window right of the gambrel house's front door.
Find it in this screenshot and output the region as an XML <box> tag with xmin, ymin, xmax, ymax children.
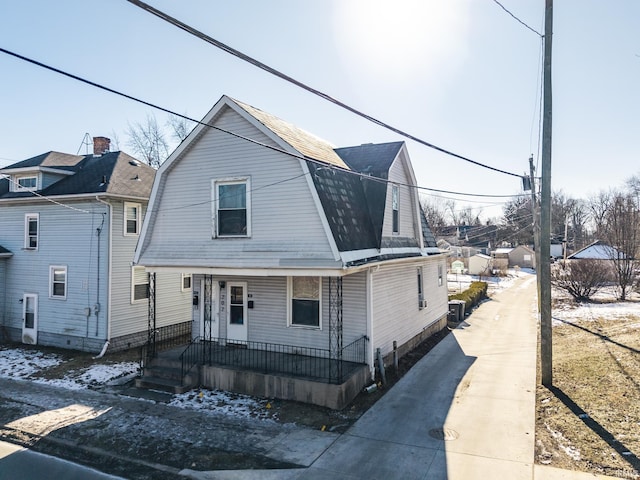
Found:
<box><xmin>288</xmin><ymin>277</ymin><xmax>322</xmax><ymax>328</ymax></box>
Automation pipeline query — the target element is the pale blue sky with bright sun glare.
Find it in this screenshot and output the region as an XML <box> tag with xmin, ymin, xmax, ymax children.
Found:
<box><xmin>0</xmin><ymin>0</ymin><xmax>640</xmax><ymax>218</ymax></box>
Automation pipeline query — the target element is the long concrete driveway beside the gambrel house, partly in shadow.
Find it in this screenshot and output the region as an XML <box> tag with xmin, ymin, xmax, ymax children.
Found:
<box><xmin>195</xmin><ymin>276</ymin><xmax>611</xmax><ymax>480</ymax></box>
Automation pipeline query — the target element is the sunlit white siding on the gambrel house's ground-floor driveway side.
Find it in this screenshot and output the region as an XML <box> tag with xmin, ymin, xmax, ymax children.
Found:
<box><xmin>372</xmin><ymin>257</ymin><xmax>448</xmax><ymax>355</ymax></box>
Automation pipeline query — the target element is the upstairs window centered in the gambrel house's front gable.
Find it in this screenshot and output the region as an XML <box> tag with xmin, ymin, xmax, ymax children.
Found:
<box><xmin>214</xmin><ymin>178</ymin><xmax>251</xmax><ymax>237</ymax></box>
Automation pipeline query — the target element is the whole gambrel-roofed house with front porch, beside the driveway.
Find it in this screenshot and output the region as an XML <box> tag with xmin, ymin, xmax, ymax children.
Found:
<box><xmin>135</xmin><ymin>96</ymin><xmax>448</xmax><ymax>408</ymax></box>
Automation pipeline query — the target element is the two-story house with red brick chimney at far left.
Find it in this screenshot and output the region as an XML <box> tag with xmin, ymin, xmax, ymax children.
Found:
<box><xmin>0</xmin><ymin>137</ymin><xmax>191</xmax><ymax>352</ymax></box>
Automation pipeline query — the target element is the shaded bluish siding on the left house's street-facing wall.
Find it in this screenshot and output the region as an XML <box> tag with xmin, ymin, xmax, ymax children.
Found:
<box><xmin>0</xmin><ymin>201</ymin><xmax>108</xmax><ymax>350</ymax></box>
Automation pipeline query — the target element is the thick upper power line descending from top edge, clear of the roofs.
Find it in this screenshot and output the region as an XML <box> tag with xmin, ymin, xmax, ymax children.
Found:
<box><xmin>127</xmin><ymin>0</ymin><xmax>522</xmax><ymax>178</ymax></box>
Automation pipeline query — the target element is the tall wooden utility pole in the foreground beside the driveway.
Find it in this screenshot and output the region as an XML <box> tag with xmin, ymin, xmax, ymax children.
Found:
<box><xmin>538</xmin><ymin>0</ymin><xmax>553</xmax><ymax>387</ymax></box>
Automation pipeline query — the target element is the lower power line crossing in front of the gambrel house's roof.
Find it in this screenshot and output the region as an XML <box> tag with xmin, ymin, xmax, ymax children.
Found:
<box><xmin>0</xmin><ymin>47</ymin><xmax>521</xmax><ymax>206</ymax></box>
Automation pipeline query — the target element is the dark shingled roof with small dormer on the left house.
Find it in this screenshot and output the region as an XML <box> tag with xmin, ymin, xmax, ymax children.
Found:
<box><xmin>0</xmin><ymin>152</ymin><xmax>155</xmax><ymax>200</ymax></box>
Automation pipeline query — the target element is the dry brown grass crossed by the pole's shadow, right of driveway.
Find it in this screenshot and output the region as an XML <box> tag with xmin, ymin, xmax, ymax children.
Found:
<box><xmin>536</xmin><ymin>306</ymin><xmax>640</xmax><ymax>479</ymax></box>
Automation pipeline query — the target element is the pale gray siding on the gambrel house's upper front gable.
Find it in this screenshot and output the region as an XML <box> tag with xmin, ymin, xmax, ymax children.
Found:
<box><xmin>142</xmin><ymin>106</ymin><xmax>333</xmax><ymax>267</ymax></box>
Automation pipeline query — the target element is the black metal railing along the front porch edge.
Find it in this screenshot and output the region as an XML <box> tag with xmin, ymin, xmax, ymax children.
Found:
<box><xmin>180</xmin><ymin>336</ymin><xmax>368</xmax><ymax>383</ymax></box>
